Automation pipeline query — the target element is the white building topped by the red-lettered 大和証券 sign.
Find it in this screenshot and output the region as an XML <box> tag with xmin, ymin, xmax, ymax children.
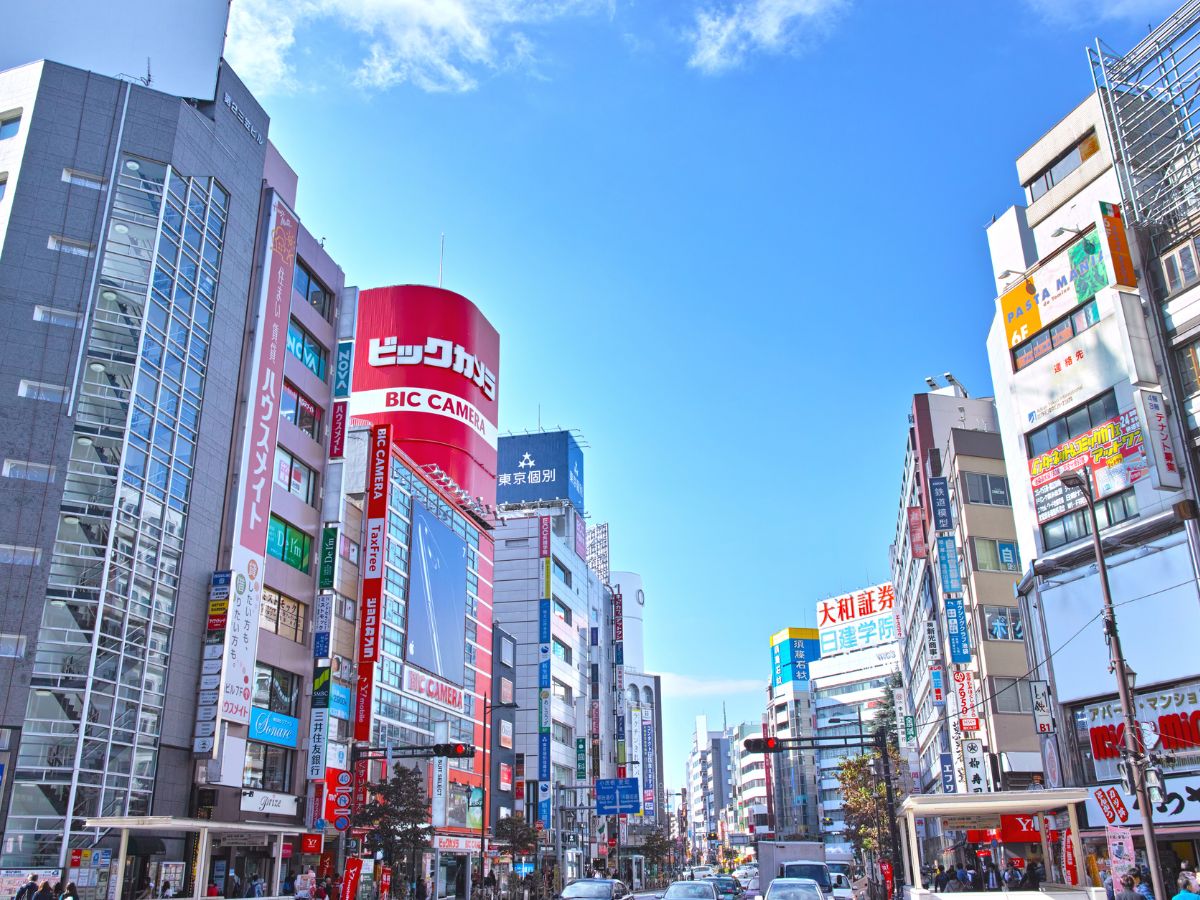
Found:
<box><xmin>808</xmin><ymin>583</ymin><xmax>899</xmax><ymax>850</ymax></box>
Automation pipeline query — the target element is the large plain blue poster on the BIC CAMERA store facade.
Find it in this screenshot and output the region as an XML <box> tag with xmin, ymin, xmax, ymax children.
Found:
<box><xmin>406</xmin><ymin>500</ymin><xmax>467</xmax><ymax>685</ymax></box>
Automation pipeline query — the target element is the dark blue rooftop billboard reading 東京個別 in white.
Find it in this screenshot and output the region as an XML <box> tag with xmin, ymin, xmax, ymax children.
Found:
<box><xmin>496</xmin><ymin>431</ymin><xmax>583</xmax><ymax>512</ymax></box>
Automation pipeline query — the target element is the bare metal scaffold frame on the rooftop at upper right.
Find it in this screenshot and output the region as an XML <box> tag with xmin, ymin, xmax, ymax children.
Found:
<box><xmin>1087</xmin><ymin>0</ymin><xmax>1200</xmax><ymax>240</ymax></box>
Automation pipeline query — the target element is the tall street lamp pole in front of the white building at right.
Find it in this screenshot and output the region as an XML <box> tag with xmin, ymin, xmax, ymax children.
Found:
<box><xmin>1058</xmin><ymin>470</ymin><xmax>1166</xmax><ymax>896</ymax></box>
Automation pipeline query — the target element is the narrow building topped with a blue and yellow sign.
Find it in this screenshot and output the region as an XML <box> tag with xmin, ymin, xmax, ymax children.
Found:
<box><xmin>754</xmin><ymin>628</ymin><xmax>821</xmax><ymax>840</ymax></box>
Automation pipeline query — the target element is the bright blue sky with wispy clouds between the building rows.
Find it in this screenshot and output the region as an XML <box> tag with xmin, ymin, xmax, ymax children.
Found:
<box><xmin>220</xmin><ymin>0</ymin><xmax>1172</xmax><ymax>788</ymax></box>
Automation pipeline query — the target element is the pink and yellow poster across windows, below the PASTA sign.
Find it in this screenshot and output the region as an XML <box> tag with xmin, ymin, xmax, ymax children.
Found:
<box><xmin>1030</xmin><ymin>409</ymin><xmax>1150</xmax><ymax>523</ymax></box>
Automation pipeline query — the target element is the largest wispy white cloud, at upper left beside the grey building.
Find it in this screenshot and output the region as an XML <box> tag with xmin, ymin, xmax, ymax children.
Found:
<box><xmin>226</xmin><ymin>0</ymin><xmax>612</xmax><ymax>94</ymax></box>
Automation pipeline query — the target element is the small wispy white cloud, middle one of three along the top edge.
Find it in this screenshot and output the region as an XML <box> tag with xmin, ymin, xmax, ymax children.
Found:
<box><xmin>688</xmin><ymin>0</ymin><xmax>847</xmax><ymax>73</ymax></box>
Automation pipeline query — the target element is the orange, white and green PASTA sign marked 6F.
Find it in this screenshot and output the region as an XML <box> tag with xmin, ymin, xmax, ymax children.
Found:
<box><xmin>997</xmin><ymin>203</ymin><xmax>1138</xmax><ymax>347</ymax></box>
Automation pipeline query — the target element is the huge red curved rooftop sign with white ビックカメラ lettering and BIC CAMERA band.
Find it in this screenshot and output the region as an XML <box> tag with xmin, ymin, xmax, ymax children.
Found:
<box><xmin>349</xmin><ymin>284</ymin><xmax>500</xmax><ymax>505</ymax></box>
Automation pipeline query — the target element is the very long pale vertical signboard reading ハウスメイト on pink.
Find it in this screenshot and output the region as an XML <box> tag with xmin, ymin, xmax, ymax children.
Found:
<box><xmin>220</xmin><ymin>191</ymin><xmax>300</xmax><ymax>725</ymax></box>
